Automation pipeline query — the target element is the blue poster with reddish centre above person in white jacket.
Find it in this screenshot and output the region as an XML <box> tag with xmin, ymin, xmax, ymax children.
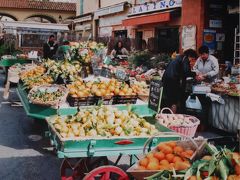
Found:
<box><xmin>203</xmin><ymin>29</ymin><xmax>216</xmax><ymax>54</ymax></box>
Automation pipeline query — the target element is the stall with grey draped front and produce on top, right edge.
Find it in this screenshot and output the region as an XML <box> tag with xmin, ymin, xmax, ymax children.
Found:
<box><xmin>210</xmin><ymin>75</ymin><xmax>240</xmax><ymax>133</ymax></box>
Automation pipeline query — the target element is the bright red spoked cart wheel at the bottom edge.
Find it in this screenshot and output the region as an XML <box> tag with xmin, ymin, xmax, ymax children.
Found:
<box><xmin>83</xmin><ymin>166</ymin><xmax>129</xmax><ymax>180</ymax></box>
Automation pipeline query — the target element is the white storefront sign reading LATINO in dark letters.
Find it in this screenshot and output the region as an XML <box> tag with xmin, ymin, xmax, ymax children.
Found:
<box><xmin>130</xmin><ymin>0</ymin><xmax>182</xmax><ymax>15</ymax></box>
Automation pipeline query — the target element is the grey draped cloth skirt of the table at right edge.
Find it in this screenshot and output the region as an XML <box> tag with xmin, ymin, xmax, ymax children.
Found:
<box><xmin>209</xmin><ymin>95</ymin><xmax>240</xmax><ymax>133</ymax></box>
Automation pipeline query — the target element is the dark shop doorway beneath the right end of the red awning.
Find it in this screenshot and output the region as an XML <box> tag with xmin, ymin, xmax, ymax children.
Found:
<box><xmin>156</xmin><ymin>28</ymin><xmax>179</xmax><ymax>54</ymax></box>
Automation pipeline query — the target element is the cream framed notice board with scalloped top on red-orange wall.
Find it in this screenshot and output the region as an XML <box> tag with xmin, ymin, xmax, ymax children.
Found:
<box><xmin>182</xmin><ymin>25</ymin><xmax>196</xmax><ymax>50</ymax></box>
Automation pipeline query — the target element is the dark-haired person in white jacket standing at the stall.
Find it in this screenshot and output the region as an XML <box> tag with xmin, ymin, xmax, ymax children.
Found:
<box><xmin>193</xmin><ymin>46</ymin><xmax>219</xmax><ymax>82</ymax></box>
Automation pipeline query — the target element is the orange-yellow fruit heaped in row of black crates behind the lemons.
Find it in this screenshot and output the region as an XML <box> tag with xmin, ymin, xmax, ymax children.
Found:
<box><xmin>67</xmin><ymin>79</ymin><xmax>136</xmax><ymax>98</ymax></box>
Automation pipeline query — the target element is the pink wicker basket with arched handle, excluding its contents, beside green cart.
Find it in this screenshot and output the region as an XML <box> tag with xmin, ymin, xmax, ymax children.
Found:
<box><xmin>157</xmin><ymin>108</ymin><xmax>200</xmax><ymax>137</ymax></box>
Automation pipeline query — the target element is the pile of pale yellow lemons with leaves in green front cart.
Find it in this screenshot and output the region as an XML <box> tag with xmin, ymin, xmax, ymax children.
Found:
<box><xmin>47</xmin><ymin>106</ymin><xmax>158</xmax><ymax>138</ymax></box>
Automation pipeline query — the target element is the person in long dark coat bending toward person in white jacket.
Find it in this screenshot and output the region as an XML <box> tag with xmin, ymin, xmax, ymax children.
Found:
<box><xmin>162</xmin><ymin>49</ymin><xmax>197</xmax><ymax>113</ymax></box>
